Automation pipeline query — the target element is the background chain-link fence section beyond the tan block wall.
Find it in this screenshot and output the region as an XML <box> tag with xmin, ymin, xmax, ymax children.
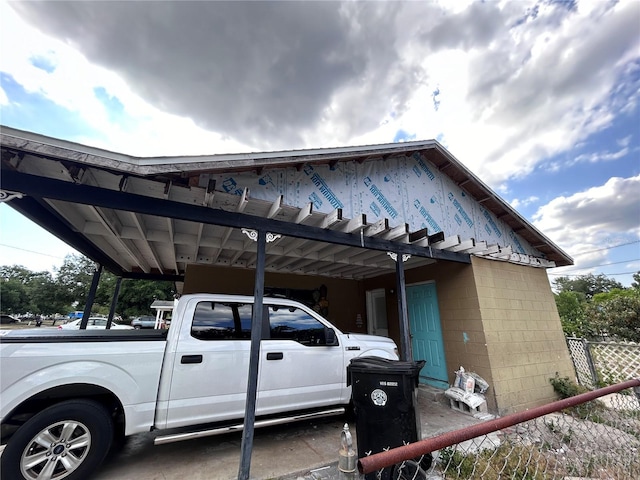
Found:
<box><xmin>567</xmin><ymin>337</ymin><xmax>640</xmax><ymax>389</ymax></box>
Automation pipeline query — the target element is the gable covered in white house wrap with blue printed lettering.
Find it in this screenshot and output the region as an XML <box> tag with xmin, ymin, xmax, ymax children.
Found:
<box><xmin>211</xmin><ymin>153</ymin><xmax>541</xmax><ymax>257</ymax></box>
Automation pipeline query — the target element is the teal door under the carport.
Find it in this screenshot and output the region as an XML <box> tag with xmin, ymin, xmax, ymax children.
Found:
<box><xmin>407</xmin><ymin>283</ymin><xmax>449</xmax><ymax>388</ymax></box>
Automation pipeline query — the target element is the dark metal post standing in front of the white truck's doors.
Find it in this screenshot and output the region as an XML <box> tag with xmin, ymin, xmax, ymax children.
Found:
<box><xmin>238</xmin><ymin>230</ymin><xmax>266</xmax><ymax>480</ymax></box>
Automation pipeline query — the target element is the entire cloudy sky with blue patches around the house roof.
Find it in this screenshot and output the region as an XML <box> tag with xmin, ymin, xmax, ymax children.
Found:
<box><xmin>0</xmin><ymin>0</ymin><xmax>640</xmax><ymax>285</ymax></box>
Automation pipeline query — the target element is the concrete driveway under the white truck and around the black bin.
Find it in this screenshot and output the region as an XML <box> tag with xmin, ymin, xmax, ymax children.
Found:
<box><xmin>93</xmin><ymin>387</ymin><xmax>480</xmax><ymax>480</ymax></box>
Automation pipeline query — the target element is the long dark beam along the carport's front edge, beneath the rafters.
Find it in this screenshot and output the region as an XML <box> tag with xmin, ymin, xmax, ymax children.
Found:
<box><xmin>2</xmin><ymin>169</ymin><xmax>471</xmax><ymax>263</ymax></box>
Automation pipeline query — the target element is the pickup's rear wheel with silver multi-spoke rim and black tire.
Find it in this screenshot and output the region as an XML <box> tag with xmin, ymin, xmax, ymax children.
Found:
<box><xmin>0</xmin><ymin>400</ymin><xmax>113</xmax><ymax>480</ymax></box>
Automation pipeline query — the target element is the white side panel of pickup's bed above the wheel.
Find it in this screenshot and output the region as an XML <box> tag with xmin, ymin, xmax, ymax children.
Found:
<box><xmin>0</xmin><ymin>329</ymin><xmax>167</xmax><ymax>434</ymax></box>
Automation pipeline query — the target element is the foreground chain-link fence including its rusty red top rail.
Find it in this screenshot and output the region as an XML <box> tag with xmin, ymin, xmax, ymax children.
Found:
<box><xmin>360</xmin><ymin>380</ymin><xmax>640</xmax><ymax>480</ymax></box>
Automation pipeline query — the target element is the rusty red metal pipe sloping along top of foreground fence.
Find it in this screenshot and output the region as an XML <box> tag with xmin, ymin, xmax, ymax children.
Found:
<box><xmin>358</xmin><ymin>378</ymin><xmax>640</xmax><ymax>474</ymax></box>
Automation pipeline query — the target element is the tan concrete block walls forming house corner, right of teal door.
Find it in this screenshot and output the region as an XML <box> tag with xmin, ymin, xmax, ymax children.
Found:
<box><xmin>405</xmin><ymin>257</ymin><xmax>574</xmax><ymax>415</ymax></box>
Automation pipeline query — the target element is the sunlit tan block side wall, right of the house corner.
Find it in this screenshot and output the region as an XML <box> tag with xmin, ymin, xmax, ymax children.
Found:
<box><xmin>472</xmin><ymin>257</ymin><xmax>574</xmax><ymax>415</ymax></box>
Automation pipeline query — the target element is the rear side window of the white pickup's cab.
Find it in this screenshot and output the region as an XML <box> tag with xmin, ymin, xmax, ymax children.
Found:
<box><xmin>191</xmin><ymin>302</ymin><xmax>252</xmax><ymax>340</ymax></box>
